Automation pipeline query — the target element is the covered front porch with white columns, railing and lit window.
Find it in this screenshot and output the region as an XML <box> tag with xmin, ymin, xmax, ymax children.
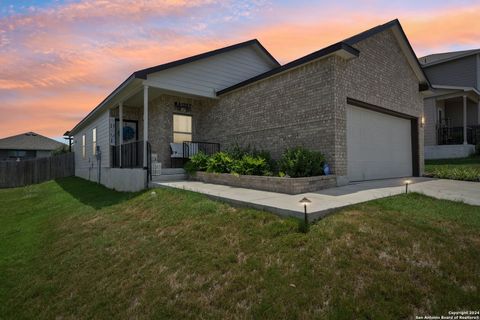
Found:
<box><xmin>109</xmin><ymin>85</ymin><xmax>220</xmax><ymax>176</ymax></box>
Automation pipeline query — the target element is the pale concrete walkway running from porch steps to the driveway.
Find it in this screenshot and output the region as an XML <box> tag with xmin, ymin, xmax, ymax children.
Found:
<box><xmin>152</xmin><ymin>178</ymin><xmax>480</xmax><ymax>220</ymax></box>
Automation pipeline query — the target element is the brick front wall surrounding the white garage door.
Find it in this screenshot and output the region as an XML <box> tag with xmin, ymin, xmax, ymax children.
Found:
<box><xmin>334</xmin><ymin>30</ymin><xmax>424</xmax><ymax>175</ymax></box>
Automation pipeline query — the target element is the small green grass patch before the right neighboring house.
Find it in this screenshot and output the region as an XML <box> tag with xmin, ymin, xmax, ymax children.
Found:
<box><xmin>425</xmin><ymin>155</ymin><xmax>480</xmax><ymax>181</ymax></box>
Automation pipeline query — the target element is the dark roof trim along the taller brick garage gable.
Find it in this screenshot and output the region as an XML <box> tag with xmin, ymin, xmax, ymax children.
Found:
<box><xmin>217</xmin><ymin>19</ymin><xmax>430</xmax><ymax>95</ymax></box>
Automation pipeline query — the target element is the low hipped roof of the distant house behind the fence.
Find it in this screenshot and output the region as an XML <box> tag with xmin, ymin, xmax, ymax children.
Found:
<box><xmin>0</xmin><ymin>132</ymin><xmax>65</xmax><ymax>150</ymax></box>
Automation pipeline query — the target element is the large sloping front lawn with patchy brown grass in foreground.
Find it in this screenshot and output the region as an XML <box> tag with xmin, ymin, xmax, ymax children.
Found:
<box><xmin>0</xmin><ymin>178</ymin><xmax>480</xmax><ymax>319</ymax></box>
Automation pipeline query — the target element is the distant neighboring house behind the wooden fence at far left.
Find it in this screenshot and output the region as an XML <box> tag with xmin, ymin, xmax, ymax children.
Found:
<box><xmin>0</xmin><ymin>132</ymin><xmax>66</xmax><ymax>160</ymax></box>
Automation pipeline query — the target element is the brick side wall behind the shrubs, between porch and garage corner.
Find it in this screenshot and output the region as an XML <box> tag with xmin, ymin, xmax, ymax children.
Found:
<box><xmin>195</xmin><ymin>58</ymin><xmax>335</xmax><ymax>168</ymax></box>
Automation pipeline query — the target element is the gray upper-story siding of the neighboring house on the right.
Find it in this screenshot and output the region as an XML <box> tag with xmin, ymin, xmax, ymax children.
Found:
<box><xmin>424</xmin><ymin>55</ymin><xmax>478</xmax><ymax>88</ymax></box>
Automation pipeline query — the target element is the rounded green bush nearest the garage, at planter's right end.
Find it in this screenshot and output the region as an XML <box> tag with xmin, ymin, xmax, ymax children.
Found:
<box><xmin>278</xmin><ymin>147</ymin><xmax>325</xmax><ymax>178</ymax></box>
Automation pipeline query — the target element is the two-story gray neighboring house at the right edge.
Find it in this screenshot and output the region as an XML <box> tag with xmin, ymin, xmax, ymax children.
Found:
<box><xmin>419</xmin><ymin>49</ymin><xmax>480</xmax><ymax>159</ymax></box>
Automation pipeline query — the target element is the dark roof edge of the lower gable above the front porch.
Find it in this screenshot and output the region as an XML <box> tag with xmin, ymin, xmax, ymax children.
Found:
<box><xmin>64</xmin><ymin>39</ymin><xmax>280</xmax><ymax>135</ymax></box>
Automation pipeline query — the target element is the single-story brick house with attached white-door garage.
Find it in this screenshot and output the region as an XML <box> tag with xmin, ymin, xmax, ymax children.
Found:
<box><xmin>69</xmin><ymin>20</ymin><xmax>429</xmax><ymax>190</ymax></box>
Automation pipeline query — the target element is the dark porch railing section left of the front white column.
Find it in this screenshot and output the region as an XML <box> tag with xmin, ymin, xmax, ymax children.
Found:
<box><xmin>110</xmin><ymin>141</ymin><xmax>143</xmax><ymax>168</ymax></box>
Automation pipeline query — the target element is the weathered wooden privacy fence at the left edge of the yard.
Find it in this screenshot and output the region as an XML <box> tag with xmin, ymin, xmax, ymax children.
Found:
<box><xmin>0</xmin><ymin>153</ymin><xmax>75</xmax><ymax>188</ymax></box>
